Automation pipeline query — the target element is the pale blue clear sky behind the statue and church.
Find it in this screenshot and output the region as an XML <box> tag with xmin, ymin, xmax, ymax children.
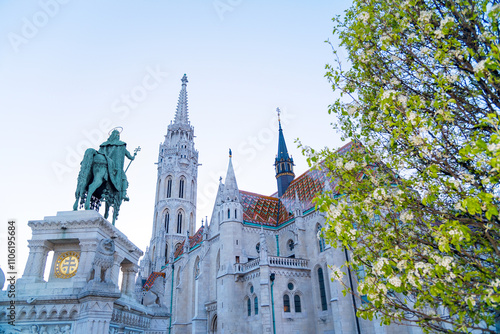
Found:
<box><xmin>0</xmin><ymin>0</ymin><xmax>350</xmax><ymax>282</ymax></box>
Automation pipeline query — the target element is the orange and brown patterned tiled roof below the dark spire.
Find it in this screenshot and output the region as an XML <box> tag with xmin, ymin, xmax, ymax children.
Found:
<box><xmin>240</xmin><ymin>142</ymin><xmax>354</xmax><ymax>226</ymax></box>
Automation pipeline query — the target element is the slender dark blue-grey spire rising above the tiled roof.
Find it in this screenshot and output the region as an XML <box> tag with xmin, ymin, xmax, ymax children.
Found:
<box><xmin>274</xmin><ymin>108</ymin><xmax>295</xmax><ymax>197</ymax></box>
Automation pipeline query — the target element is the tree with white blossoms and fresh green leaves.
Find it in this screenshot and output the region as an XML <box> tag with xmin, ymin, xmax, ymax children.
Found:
<box><xmin>304</xmin><ymin>0</ymin><xmax>500</xmax><ymax>332</ymax></box>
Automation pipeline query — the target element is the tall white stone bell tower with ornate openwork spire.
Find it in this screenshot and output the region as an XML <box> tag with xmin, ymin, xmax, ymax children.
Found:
<box><xmin>142</xmin><ymin>74</ymin><xmax>198</xmax><ymax>275</ymax></box>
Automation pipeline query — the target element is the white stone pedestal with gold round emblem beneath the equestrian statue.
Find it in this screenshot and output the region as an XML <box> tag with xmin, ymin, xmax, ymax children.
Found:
<box><xmin>0</xmin><ymin>210</ymin><xmax>170</xmax><ymax>334</ymax></box>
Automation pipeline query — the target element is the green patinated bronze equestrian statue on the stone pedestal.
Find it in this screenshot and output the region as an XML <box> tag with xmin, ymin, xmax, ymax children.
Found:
<box><xmin>73</xmin><ymin>130</ymin><xmax>141</xmax><ymax>225</ymax></box>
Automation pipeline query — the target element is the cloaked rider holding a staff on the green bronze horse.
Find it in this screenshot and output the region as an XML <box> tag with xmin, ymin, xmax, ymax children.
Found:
<box><xmin>99</xmin><ymin>130</ymin><xmax>135</xmax><ymax>201</ymax></box>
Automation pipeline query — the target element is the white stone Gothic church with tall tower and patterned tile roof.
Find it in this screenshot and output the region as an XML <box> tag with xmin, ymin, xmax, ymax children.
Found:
<box><xmin>139</xmin><ymin>76</ymin><xmax>420</xmax><ymax>334</ymax></box>
